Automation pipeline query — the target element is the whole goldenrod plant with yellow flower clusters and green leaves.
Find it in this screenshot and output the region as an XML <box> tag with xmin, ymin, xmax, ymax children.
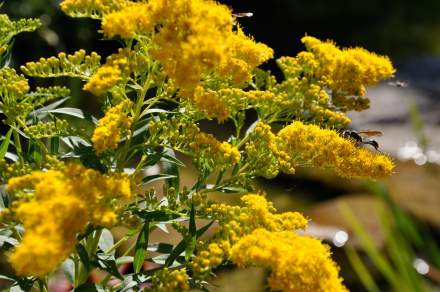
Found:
<box><xmin>0</xmin><ymin>0</ymin><xmax>394</xmax><ymax>291</ymax></box>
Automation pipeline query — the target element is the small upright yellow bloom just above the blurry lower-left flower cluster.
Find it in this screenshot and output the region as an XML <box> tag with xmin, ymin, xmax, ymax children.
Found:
<box><xmin>92</xmin><ymin>101</ymin><xmax>132</xmax><ymax>154</ymax></box>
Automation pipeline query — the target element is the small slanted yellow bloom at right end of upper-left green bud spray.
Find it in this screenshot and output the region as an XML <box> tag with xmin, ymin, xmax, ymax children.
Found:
<box><xmin>83</xmin><ymin>50</ymin><xmax>128</xmax><ymax>96</ymax></box>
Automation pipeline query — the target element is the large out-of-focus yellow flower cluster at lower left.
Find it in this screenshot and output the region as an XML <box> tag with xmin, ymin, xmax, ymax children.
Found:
<box><xmin>7</xmin><ymin>164</ymin><xmax>131</xmax><ymax>277</ymax></box>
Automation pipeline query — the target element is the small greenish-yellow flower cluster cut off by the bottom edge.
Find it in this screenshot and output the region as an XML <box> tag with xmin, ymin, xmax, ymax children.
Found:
<box><xmin>152</xmin><ymin>268</ymin><xmax>190</xmax><ymax>292</ymax></box>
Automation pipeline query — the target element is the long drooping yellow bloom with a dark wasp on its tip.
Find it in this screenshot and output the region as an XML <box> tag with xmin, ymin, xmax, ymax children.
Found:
<box><xmin>277</xmin><ymin>121</ymin><xmax>394</xmax><ymax>178</ymax></box>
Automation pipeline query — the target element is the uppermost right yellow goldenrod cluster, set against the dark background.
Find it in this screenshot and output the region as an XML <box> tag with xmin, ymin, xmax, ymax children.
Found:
<box><xmin>278</xmin><ymin>36</ymin><xmax>394</xmax><ymax>111</ymax></box>
